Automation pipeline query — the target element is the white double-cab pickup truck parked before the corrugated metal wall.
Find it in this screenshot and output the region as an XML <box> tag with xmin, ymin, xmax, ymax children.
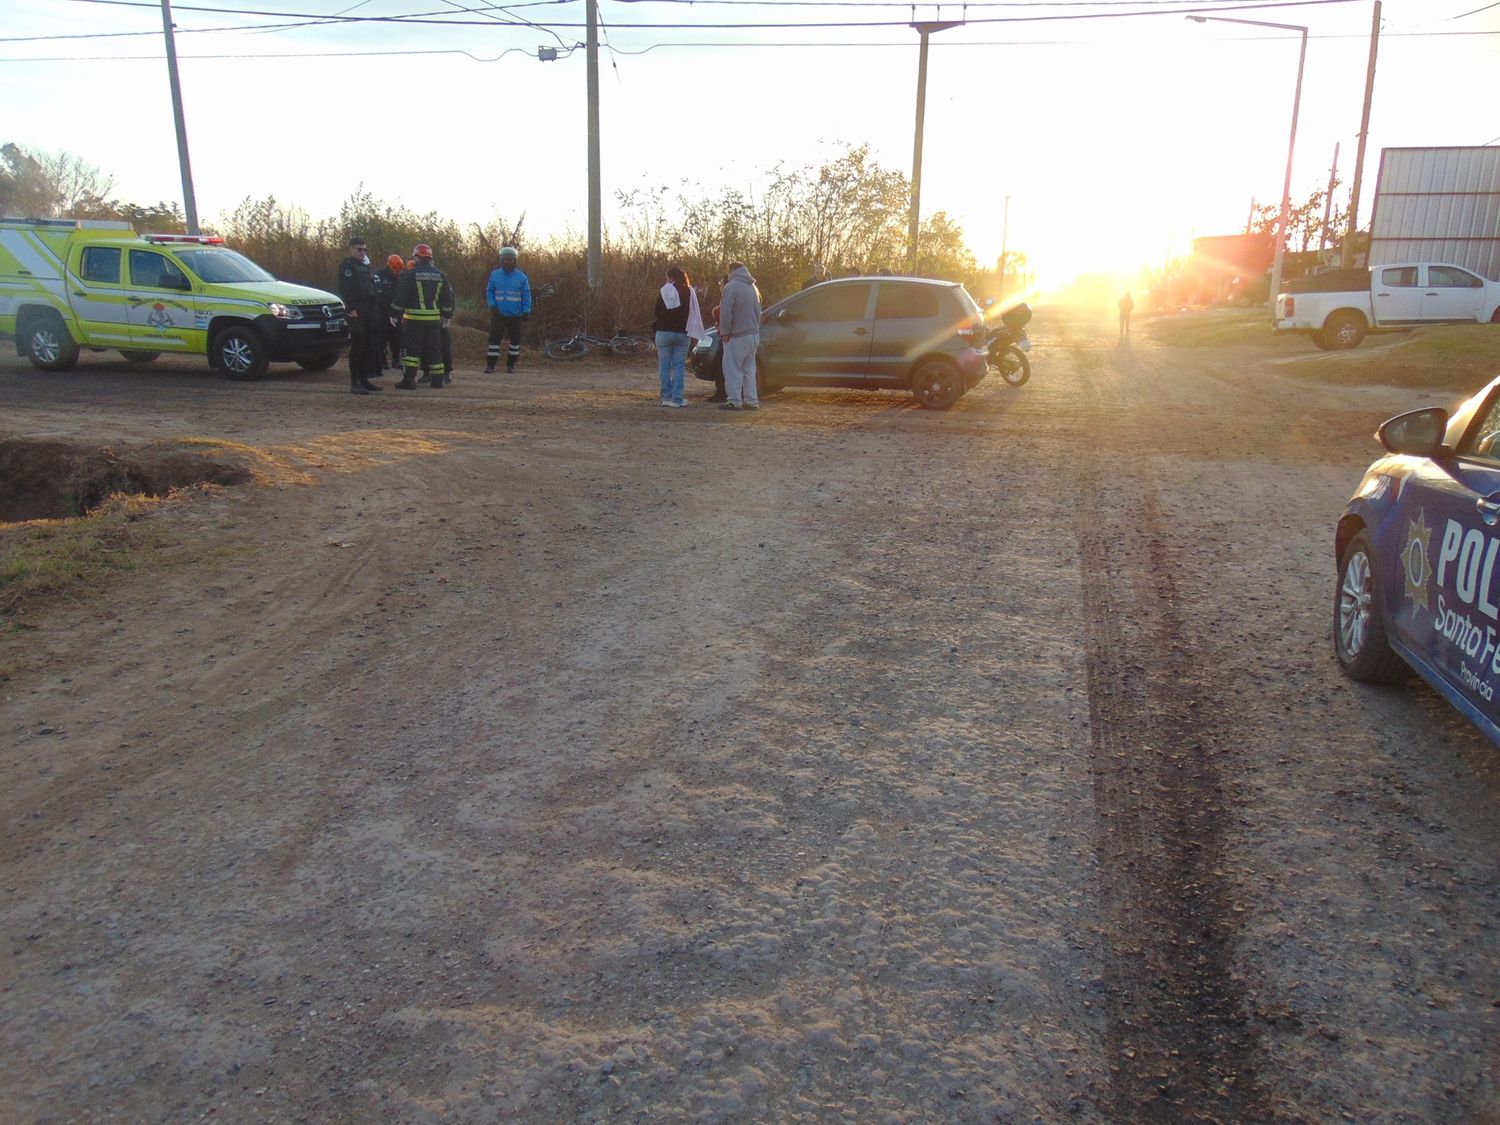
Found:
<box><xmin>1277</xmin><ymin>263</ymin><xmax>1500</xmax><ymax>350</ymax></box>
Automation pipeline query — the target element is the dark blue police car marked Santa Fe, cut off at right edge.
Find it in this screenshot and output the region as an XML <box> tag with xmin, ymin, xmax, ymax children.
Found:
<box><xmin>1334</xmin><ymin>378</ymin><xmax>1500</xmax><ymax>744</ymax></box>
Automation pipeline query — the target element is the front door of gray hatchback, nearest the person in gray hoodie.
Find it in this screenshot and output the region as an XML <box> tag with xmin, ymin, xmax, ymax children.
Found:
<box><xmin>761</xmin><ymin>282</ymin><xmax>875</xmax><ymax>381</ymax></box>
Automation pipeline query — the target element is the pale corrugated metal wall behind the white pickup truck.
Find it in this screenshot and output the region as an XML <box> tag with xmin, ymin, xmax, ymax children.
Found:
<box><xmin>1370</xmin><ymin>146</ymin><xmax>1500</xmax><ymax>281</ymax></box>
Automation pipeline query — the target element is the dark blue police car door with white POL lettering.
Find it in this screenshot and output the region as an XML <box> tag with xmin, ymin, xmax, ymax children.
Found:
<box><xmin>1379</xmin><ymin>392</ymin><xmax>1500</xmax><ymax>719</ymax></box>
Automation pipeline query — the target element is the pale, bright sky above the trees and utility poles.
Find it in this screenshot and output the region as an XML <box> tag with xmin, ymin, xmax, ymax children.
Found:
<box><xmin>0</xmin><ymin>0</ymin><xmax>1500</xmax><ymax>282</ymax></box>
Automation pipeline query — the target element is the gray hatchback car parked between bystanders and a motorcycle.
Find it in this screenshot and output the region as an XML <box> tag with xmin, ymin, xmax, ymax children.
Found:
<box><xmin>693</xmin><ymin>276</ymin><xmax>987</xmax><ymax>410</ymax></box>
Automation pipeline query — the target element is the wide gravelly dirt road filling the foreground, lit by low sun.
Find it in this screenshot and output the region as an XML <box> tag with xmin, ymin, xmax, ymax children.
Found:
<box><xmin>0</xmin><ymin>314</ymin><xmax>1500</xmax><ymax>1122</ymax></box>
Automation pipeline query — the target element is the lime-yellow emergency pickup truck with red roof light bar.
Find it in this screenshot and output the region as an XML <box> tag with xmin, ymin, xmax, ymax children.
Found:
<box><xmin>0</xmin><ymin>219</ymin><xmax>350</xmax><ymax>380</ymax></box>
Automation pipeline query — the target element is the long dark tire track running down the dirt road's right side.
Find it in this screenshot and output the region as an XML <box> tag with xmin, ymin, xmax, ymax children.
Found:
<box><xmin>1074</xmin><ymin>324</ymin><xmax>1271</xmax><ymax>1121</ymax></box>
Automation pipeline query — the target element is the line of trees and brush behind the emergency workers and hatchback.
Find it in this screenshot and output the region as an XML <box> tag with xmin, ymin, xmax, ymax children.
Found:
<box><xmin>0</xmin><ymin>144</ymin><xmax>1025</xmax><ymax>336</ymax></box>
